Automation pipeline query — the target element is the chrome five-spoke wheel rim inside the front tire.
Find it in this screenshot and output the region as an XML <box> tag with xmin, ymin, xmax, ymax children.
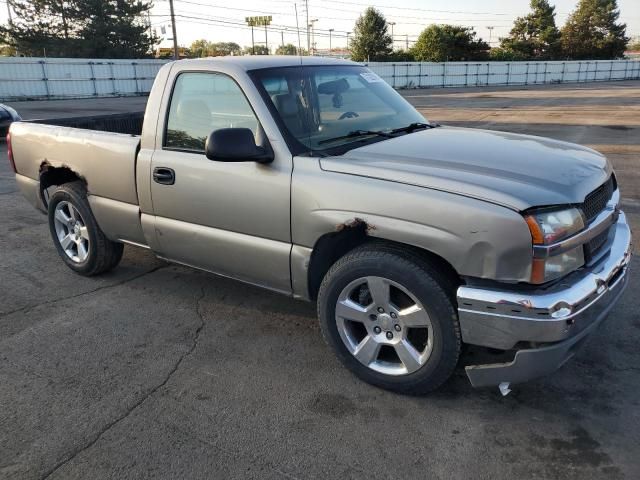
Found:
<box><xmin>336</xmin><ymin>276</ymin><xmax>433</xmax><ymax>375</ymax></box>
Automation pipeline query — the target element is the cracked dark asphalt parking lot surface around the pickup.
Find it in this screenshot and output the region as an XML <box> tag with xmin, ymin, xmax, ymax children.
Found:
<box><xmin>0</xmin><ymin>82</ymin><xmax>640</xmax><ymax>480</ymax></box>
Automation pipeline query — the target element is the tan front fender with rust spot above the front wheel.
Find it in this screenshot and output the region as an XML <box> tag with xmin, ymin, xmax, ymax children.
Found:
<box><xmin>291</xmin><ymin>158</ymin><xmax>532</xmax><ymax>294</ymax></box>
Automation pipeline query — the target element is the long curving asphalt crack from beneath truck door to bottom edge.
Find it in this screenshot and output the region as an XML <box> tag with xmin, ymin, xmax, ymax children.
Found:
<box><xmin>40</xmin><ymin>286</ymin><xmax>205</xmax><ymax>480</ymax></box>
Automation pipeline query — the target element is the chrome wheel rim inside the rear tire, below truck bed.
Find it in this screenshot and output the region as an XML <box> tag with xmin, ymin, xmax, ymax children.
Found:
<box><xmin>54</xmin><ymin>201</ymin><xmax>90</xmax><ymax>263</ymax></box>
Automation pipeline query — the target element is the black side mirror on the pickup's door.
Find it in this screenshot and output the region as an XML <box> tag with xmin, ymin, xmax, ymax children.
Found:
<box><xmin>204</xmin><ymin>128</ymin><xmax>273</xmax><ymax>163</ymax></box>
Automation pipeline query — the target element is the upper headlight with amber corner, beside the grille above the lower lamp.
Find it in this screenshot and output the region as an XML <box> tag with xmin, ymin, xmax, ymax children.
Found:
<box><xmin>524</xmin><ymin>208</ymin><xmax>584</xmax><ymax>245</ymax></box>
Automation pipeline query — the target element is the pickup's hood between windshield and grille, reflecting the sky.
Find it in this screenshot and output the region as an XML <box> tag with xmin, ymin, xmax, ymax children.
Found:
<box><xmin>320</xmin><ymin>127</ymin><xmax>611</xmax><ymax>211</ymax></box>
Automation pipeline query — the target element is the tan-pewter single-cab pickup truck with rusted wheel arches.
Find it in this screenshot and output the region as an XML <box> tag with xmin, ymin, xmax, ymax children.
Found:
<box><xmin>8</xmin><ymin>56</ymin><xmax>631</xmax><ymax>394</ymax></box>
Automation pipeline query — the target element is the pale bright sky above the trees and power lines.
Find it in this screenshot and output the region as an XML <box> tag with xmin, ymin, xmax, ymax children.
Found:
<box><xmin>0</xmin><ymin>0</ymin><xmax>640</xmax><ymax>49</ymax></box>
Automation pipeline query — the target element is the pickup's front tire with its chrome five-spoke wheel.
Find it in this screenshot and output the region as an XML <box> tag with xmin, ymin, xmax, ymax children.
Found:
<box><xmin>318</xmin><ymin>244</ymin><xmax>461</xmax><ymax>394</ymax></box>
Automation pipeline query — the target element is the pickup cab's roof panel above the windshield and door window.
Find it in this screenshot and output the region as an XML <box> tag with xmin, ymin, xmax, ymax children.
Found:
<box><xmin>172</xmin><ymin>55</ymin><xmax>359</xmax><ymax>71</ymax></box>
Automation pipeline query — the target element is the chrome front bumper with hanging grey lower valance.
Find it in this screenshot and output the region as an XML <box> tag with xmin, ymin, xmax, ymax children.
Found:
<box><xmin>457</xmin><ymin>213</ymin><xmax>631</xmax><ymax>387</ymax></box>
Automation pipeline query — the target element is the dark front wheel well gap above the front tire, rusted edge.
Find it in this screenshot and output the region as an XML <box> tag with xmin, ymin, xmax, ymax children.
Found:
<box><xmin>308</xmin><ymin>219</ymin><xmax>462</xmax><ymax>300</ymax></box>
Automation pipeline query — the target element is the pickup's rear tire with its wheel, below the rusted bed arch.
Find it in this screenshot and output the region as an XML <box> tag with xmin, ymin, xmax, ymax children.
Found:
<box><xmin>48</xmin><ymin>181</ymin><xmax>124</xmax><ymax>277</ymax></box>
